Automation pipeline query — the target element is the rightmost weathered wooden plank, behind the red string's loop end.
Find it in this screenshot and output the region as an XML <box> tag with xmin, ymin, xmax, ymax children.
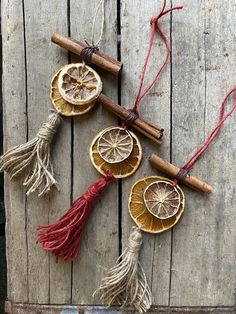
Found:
<box><xmin>171</xmin><ymin>0</ymin><xmax>236</xmax><ymax>306</ymax></box>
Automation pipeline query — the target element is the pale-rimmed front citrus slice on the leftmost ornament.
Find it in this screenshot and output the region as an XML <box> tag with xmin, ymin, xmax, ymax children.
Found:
<box><xmin>58</xmin><ymin>63</ymin><xmax>102</xmax><ymax>105</ymax></box>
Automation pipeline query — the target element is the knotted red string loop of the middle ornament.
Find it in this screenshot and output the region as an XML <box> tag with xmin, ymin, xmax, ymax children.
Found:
<box><xmin>132</xmin><ymin>0</ymin><xmax>183</xmax><ymax>114</ymax></box>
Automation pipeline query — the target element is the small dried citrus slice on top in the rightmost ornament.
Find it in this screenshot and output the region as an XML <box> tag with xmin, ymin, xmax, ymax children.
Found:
<box><xmin>143</xmin><ymin>180</ymin><xmax>181</xmax><ymax>219</ymax></box>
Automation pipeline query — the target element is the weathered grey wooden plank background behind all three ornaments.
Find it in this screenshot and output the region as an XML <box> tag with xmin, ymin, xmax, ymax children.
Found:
<box><xmin>2</xmin><ymin>0</ymin><xmax>236</xmax><ymax>308</ymax></box>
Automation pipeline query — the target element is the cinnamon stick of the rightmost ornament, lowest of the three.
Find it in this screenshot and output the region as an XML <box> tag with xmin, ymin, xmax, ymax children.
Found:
<box><xmin>149</xmin><ymin>154</ymin><xmax>213</xmax><ymax>193</ymax></box>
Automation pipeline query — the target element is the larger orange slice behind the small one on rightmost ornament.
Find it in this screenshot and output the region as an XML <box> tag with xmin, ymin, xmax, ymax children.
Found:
<box><xmin>128</xmin><ymin>176</ymin><xmax>185</xmax><ymax>233</ymax></box>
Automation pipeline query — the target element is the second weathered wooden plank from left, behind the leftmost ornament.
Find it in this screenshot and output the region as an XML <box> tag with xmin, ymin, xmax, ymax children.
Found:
<box><xmin>24</xmin><ymin>0</ymin><xmax>71</xmax><ymax>303</ymax></box>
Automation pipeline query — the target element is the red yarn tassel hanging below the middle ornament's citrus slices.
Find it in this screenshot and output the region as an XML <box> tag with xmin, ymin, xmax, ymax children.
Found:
<box><xmin>38</xmin><ymin>172</ymin><xmax>113</xmax><ymax>261</ymax></box>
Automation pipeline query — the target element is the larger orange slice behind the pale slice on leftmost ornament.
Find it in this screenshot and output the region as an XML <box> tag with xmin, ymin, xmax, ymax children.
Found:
<box><xmin>50</xmin><ymin>67</ymin><xmax>96</xmax><ymax>116</ymax></box>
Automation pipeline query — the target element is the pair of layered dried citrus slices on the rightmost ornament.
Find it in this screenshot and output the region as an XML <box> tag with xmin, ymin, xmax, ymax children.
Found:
<box><xmin>129</xmin><ymin>176</ymin><xmax>185</xmax><ymax>233</ymax></box>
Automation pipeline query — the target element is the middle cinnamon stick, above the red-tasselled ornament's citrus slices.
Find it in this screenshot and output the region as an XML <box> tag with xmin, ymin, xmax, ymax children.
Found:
<box><xmin>98</xmin><ymin>94</ymin><xmax>163</xmax><ymax>145</ymax></box>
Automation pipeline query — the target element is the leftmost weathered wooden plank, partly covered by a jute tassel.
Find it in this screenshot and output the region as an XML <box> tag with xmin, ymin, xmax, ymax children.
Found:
<box><xmin>1</xmin><ymin>1</ymin><xmax>28</xmax><ymax>302</ymax></box>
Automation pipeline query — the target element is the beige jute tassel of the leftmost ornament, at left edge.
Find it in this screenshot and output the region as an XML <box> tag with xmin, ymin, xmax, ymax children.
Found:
<box><xmin>0</xmin><ymin>112</ymin><xmax>61</xmax><ymax>196</ymax></box>
